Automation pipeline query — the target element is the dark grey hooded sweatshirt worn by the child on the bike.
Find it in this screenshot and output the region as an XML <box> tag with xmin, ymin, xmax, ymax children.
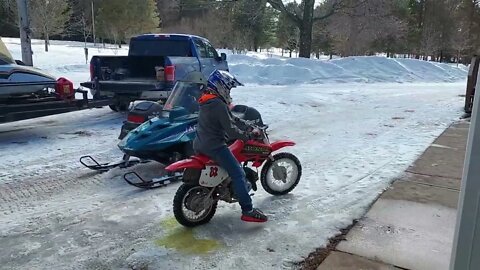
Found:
<box><xmin>193</xmin><ymin>97</ymin><xmax>249</xmax><ymax>154</ymax></box>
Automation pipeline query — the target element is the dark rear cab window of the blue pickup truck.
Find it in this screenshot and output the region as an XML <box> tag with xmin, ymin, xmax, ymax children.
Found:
<box><xmin>128</xmin><ymin>39</ymin><xmax>193</xmax><ymax>57</ymax></box>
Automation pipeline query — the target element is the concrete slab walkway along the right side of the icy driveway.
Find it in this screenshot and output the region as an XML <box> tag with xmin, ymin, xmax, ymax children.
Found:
<box><xmin>317</xmin><ymin>122</ymin><xmax>469</xmax><ymax>270</ymax></box>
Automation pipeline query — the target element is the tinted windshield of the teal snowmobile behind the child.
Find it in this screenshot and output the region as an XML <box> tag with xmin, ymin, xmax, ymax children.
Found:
<box><xmin>163</xmin><ymin>81</ymin><xmax>203</xmax><ymax>114</ymax></box>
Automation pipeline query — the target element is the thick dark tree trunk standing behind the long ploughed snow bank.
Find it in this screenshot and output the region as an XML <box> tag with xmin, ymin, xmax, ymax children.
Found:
<box><xmin>298</xmin><ymin>0</ymin><xmax>315</xmax><ymax>58</ymax></box>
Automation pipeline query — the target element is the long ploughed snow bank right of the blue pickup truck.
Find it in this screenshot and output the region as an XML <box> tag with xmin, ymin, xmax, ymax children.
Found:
<box><xmin>228</xmin><ymin>53</ymin><xmax>467</xmax><ymax>85</ymax></box>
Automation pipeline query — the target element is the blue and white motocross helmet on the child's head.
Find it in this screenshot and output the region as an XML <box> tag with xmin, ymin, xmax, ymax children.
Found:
<box><xmin>207</xmin><ymin>70</ymin><xmax>243</xmax><ymax>104</ymax></box>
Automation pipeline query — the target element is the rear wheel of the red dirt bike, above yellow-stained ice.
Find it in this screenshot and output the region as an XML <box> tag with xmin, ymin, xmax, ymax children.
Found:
<box><xmin>173</xmin><ymin>184</ymin><xmax>218</xmax><ymax>227</ymax></box>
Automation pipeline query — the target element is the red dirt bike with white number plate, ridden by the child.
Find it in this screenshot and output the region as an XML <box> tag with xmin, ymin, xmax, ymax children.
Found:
<box><xmin>166</xmin><ymin>127</ymin><xmax>302</xmax><ymax>227</ymax></box>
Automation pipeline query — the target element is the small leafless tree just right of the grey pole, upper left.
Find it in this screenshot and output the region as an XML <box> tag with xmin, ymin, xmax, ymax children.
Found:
<box><xmin>29</xmin><ymin>0</ymin><xmax>71</xmax><ymax>52</ymax></box>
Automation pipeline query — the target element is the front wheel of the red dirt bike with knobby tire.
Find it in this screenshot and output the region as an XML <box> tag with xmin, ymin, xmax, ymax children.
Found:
<box><xmin>260</xmin><ymin>153</ymin><xmax>302</xmax><ymax>195</ymax></box>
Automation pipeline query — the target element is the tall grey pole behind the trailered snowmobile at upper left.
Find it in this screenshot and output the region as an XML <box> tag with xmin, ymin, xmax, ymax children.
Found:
<box><xmin>17</xmin><ymin>0</ymin><xmax>33</xmax><ymax>66</ymax></box>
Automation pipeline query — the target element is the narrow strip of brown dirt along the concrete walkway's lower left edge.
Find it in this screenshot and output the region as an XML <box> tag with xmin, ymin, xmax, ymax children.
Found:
<box><xmin>296</xmin><ymin>220</ymin><xmax>358</xmax><ymax>270</ymax></box>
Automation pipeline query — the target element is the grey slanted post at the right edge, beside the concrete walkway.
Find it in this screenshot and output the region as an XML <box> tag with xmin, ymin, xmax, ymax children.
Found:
<box><xmin>450</xmin><ymin>66</ymin><xmax>480</xmax><ymax>270</ymax></box>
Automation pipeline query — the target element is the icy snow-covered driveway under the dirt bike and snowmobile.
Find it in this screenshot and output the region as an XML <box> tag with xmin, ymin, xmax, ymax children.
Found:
<box><xmin>0</xmin><ymin>84</ymin><xmax>464</xmax><ymax>269</ymax></box>
